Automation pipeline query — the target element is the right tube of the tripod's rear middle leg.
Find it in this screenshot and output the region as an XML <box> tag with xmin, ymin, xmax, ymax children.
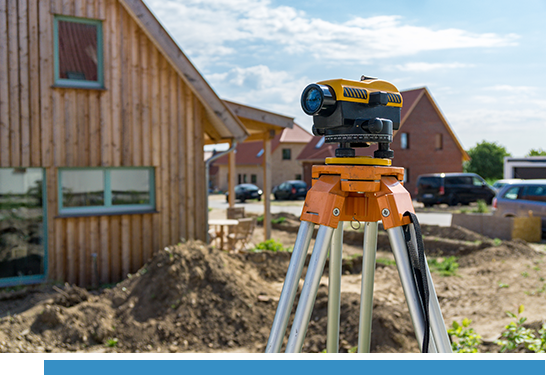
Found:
<box><xmin>358</xmin><ymin>222</ymin><xmax>378</xmax><ymax>354</ymax></box>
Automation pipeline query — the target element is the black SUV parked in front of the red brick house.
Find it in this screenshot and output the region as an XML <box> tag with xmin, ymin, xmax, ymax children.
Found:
<box><xmin>416</xmin><ymin>173</ymin><xmax>496</xmax><ymax>207</ymax></box>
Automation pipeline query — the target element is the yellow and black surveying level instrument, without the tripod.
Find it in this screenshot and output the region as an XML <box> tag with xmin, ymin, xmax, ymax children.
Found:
<box><xmin>301</xmin><ymin>76</ymin><xmax>402</xmax><ymax>159</ymax></box>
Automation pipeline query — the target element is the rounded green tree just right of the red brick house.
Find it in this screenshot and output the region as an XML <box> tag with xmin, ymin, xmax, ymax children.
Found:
<box><xmin>463</xmin><ymin>141</ymin><xmax>511</xmax><ymax>180</ymax></box>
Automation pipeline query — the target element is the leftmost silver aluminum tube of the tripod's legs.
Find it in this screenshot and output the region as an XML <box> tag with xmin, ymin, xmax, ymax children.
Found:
<box><xmin>265</xmin><ymin>221</ymin><xmax>315</xmax><ymax>354</ymax></box>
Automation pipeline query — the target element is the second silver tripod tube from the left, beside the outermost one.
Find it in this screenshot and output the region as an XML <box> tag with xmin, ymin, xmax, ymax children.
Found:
<box><xmin>285</xmin><ymin>225</ymin><xmax>334</xmax><ymax>354</ymax></box>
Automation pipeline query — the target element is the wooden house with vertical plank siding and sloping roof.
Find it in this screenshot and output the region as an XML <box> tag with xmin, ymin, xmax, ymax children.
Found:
<box><xmin>0</xmin><ymin>0</ymin><xmax>249</xmax><ymax>285</ymax></box>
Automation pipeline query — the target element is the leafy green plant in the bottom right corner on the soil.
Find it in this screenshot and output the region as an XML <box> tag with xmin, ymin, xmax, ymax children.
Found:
<box><xmin>495</xmin><ymin>305</ymin><xmax>546</xmax><ymax>354</ymax></box>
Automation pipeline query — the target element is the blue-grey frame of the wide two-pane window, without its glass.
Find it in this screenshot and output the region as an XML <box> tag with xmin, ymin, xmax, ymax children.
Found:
<box><xmin>57</xmin><ymin>167</ymin><xmax>158</xmax><ymax>217</ymax></box>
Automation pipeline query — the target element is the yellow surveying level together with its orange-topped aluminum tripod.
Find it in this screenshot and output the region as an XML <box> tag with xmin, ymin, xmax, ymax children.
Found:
<box><xmin>266</xmin><ymin>77</ymin><xmax>452</xmax><ymax>354</ymax></box>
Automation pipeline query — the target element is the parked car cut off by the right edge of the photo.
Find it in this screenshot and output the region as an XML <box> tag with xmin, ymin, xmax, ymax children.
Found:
<box><xmin>493</xmin><ymin>180</ymin><xmax>546</xmax><ymax>234</ymax></box>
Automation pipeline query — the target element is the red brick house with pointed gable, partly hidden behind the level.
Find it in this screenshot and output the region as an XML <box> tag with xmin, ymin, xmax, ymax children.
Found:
<box><xmin>297</xmin><ymin>87</ymin><xmax>470</xmax><ymax>194</ymax></box>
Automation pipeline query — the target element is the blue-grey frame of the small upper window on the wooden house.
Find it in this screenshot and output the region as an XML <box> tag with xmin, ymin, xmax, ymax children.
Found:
<box><xmin>53</xmin><ymin>14</ymin><xmax>105</xmax><ymax>90</ymax></box>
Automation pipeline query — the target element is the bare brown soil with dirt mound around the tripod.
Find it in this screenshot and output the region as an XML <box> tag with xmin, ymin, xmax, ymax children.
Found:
<box><xmin>0</xmin><ymin>214</ymin><xmax>546</xmax><ymax>354</ymax></box>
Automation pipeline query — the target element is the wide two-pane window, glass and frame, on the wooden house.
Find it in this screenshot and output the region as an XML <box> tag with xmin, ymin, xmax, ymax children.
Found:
<box><xmin>59</xmin><ymin>167</ymin><xmax>155</xmax><ymax>215</ymax></box>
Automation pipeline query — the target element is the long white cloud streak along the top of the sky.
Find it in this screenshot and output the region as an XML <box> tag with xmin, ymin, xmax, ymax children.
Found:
<box><xmin>142</xmin><ymin>0</ymin><xmax>518</xmax><ymax>63</ymax></box>
